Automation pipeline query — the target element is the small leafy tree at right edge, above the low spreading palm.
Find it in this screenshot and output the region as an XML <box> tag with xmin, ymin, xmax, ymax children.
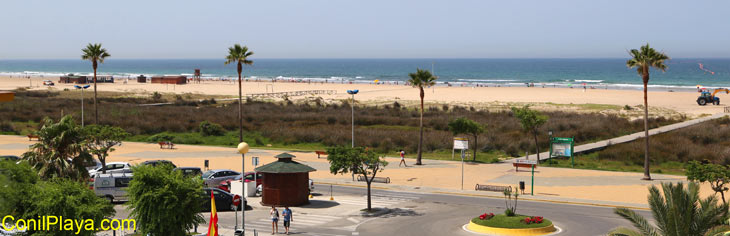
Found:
<box><xmin>687</xmin><ymin>161</ymin><xmax>730</xmax><ymax>203</ymax></box>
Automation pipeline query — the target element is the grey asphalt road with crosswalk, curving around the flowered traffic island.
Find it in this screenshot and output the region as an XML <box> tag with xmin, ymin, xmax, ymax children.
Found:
<box><xmin>115</xmin><ymin>186</ymin><xmax>651</xmax><ymax>236</ymax></box>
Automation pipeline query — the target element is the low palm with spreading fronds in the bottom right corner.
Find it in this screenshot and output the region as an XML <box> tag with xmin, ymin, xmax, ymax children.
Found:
<box><xmin>608</xmin><ymin>182</ymin><xmax>730</xmax><ymax>236</ymax></box>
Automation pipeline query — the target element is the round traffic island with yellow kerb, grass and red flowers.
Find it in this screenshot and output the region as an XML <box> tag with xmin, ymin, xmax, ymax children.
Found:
<box><xmin>465</xmin><ymin>214</ymin><xmax>558</xmax><ymax>236</ymax></box>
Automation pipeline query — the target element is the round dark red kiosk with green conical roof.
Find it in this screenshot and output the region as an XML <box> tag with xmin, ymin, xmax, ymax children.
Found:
<box><xmin>256</xmin><ymin>153</ymin><xmax>316</xmax><ymax>206</ymax></box>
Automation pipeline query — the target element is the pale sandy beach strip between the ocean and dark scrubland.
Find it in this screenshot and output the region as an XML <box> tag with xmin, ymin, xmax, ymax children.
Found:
<box><xmin>0</xmin><ymin>76</ymin><xmax>730</xmax><ymax>116</ymax></box>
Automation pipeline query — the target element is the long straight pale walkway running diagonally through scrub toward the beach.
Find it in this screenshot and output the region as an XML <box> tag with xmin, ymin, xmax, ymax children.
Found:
<box><xmin>507</xmin><ymin>113</ymin><xmax>728</xmax><ymax>162</ymax></box>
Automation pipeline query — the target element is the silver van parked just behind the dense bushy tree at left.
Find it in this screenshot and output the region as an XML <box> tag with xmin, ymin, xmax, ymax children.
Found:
<box><xmin>92</xmin><ymin>173</ymin><xmax>132</xmax><ymax>203</ymax></box>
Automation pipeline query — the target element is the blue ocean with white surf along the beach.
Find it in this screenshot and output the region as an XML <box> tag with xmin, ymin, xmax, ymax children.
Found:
<box><xmin>0</xmin><ymin>58</ymin><xmax>730</xmax><ymax>90</ymax></box>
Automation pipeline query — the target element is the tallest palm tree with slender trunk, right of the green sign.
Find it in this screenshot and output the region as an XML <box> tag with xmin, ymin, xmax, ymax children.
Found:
<box><xmin>626</xmin><ymin>43</ymin><xmax>669</xmax><ymax>180</ymax></box>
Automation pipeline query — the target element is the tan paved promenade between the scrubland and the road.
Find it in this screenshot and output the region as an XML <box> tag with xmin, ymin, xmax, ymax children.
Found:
<box><xmin>0</xmin><ymin>135</ymin><xmax>714</xmax><ymax>207</ymax></box>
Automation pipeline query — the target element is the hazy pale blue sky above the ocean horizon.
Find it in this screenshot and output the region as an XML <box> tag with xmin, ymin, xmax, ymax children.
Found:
<box><xmin>0</xmin><ymin>0</ymin><xmax>730</xmax><ymax>59</ymax></box>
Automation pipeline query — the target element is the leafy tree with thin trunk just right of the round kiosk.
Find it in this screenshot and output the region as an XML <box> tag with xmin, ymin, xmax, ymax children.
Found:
<box><xmin>327</xmin><ymin>147</ymin><xmax>388</xmax><ymax>211</ymax></box>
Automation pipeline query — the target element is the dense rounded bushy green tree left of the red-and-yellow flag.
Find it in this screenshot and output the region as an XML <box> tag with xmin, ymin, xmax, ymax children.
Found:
<box><xmin>127</xmin><ymin>165</ymin><xmax>203</xmax><ymax>236</ymax></box>
